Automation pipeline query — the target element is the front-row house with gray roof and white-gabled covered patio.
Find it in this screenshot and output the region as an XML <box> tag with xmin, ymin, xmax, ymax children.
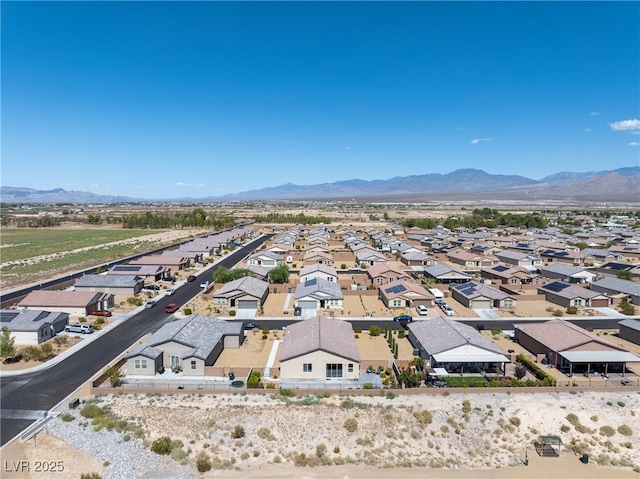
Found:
<box><xmin>407</xmin><ymin>317</ymin><xmax>509</xmax><ymax>373</ymax></box>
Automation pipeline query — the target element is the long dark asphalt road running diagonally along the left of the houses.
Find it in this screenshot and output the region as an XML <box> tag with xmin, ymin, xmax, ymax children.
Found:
<box><xmin>0</xmin><ymin>236</ymin><xmax>270</xmax><ymax>446</ymax></box>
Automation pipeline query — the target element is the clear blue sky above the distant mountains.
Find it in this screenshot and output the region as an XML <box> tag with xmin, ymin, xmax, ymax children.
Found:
<box><xmin>1</xmin><ymin>1</ymin><xmax>640</xmax><ymax>199</ymax></box>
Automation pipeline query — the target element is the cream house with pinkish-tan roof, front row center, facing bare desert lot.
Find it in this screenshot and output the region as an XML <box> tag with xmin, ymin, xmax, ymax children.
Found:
<box><xmin>279</xmin><ymin>317</ymin><xmax>360</xmax><ymax>380</ymax></box>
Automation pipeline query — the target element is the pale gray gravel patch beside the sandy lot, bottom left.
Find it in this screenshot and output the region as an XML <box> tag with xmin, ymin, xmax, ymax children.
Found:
<box><xmin>48</xmin><ymin>415</ymin><xmax>197</xmax><ymax>479</ymax></box>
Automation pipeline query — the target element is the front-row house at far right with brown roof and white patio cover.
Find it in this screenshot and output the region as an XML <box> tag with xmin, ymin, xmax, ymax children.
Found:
<box><xmin>514</xmin><ymin>319</ymin><xmax>640</xmax><ymax>375</ymax></box>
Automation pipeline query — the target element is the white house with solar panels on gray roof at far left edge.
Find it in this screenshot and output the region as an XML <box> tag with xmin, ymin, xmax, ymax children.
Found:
<box><xmin>0</xmin><ymin>309</ymin><xmax>69</xmax><ymax>346</ymax></box>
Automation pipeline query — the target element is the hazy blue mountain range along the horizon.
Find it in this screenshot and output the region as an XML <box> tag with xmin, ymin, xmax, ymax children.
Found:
<box><xmin>0</xmin><ymin>166</ymin><xmax>640</xmax><ymax>204</ymax></box>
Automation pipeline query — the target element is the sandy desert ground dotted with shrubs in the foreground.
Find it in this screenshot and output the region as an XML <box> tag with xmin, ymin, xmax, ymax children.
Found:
<box><xmin>3</xmin><ymin>392</ymin><xmax>640</xmax><ymax>479</ymax></box>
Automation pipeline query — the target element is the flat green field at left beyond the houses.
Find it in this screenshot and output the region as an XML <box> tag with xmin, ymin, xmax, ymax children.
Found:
<box><xmin>0</xmin><ymin>228</ymin><xmax>184</xmax><ymax>287</ymax></box>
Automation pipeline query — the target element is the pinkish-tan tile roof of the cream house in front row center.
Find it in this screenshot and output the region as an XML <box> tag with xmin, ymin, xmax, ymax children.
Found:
<box><xmin>280</xmin><ymin>316</ymin><xmax>360</xmax><ymax>362</ymax></box>
